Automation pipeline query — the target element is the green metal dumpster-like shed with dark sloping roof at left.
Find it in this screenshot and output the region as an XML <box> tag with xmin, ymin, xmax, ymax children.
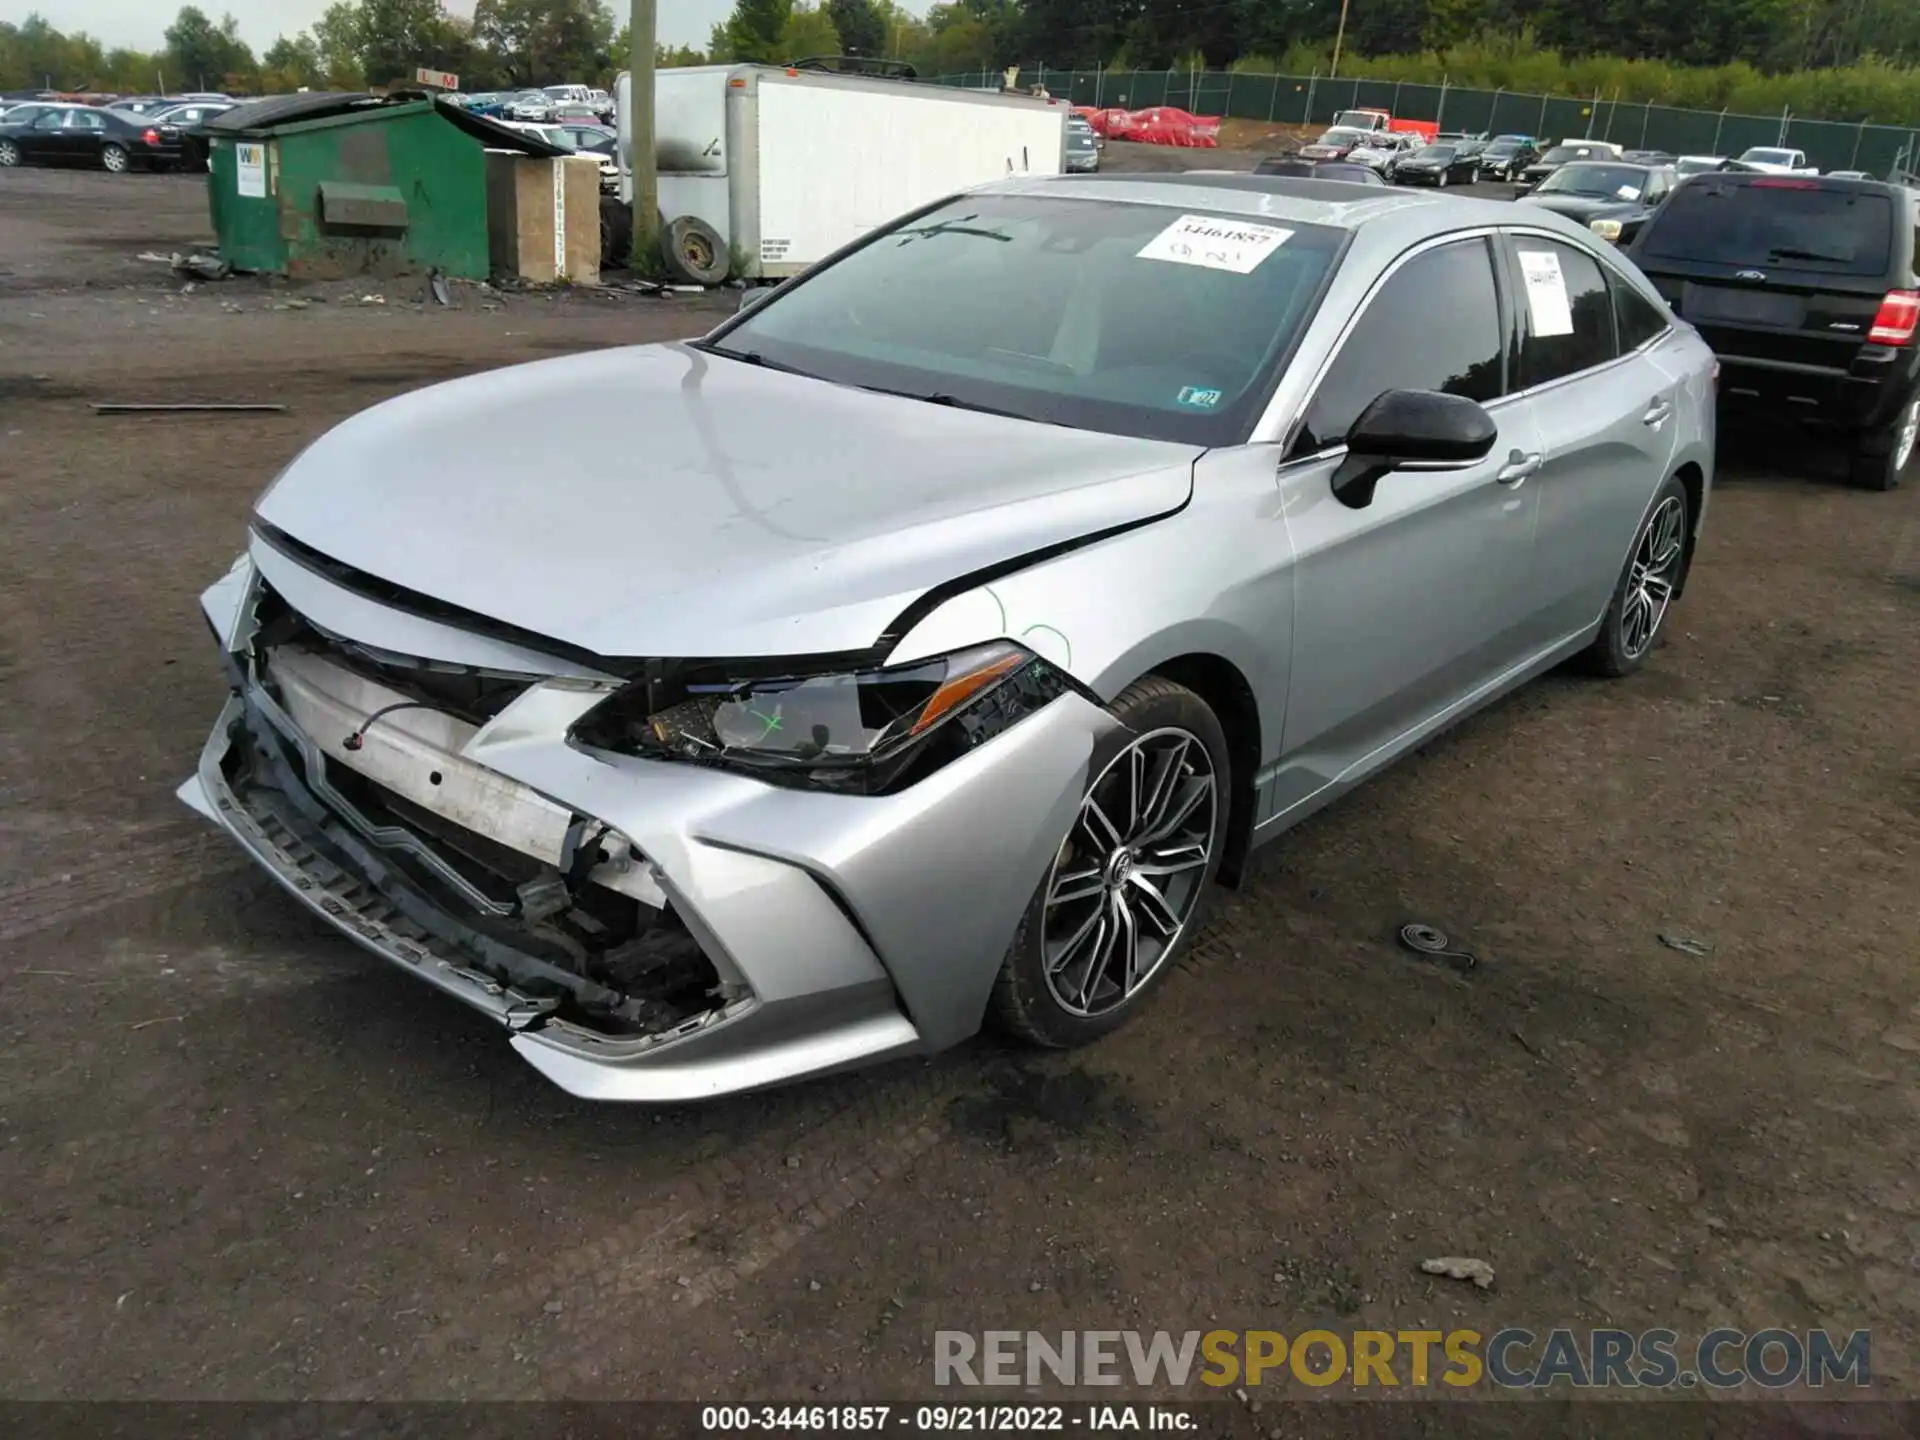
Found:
<box><xmin>207</xmin><ymin>96</ymin><xmax>490</xmax><ymax>280</ymax></box>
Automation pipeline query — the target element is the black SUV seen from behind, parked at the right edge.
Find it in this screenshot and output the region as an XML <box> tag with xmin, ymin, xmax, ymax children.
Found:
<box><xmin>1628</xmin><ymin>171</ymin><xmax>1920</xmax><ymax>490</ymax></box>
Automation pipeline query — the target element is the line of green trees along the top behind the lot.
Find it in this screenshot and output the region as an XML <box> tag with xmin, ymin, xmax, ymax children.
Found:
<box><xmin>11</xmin><ymin>0</ymin><xmax>1920</xmax><ymax>125</ymax></box>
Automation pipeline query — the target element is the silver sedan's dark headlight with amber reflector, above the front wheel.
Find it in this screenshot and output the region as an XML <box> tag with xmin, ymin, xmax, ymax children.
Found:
<box><xmin>568</xmin><ymin>639</ymin><xmax>1073</xmax><ymax>795</ymax></box>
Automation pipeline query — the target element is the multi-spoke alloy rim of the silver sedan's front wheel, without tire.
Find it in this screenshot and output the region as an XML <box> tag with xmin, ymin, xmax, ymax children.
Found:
<box><xmin>1041</xmin><ymin>728</ymin><xmax>1219</xmax><ymax>1018</ymax></box>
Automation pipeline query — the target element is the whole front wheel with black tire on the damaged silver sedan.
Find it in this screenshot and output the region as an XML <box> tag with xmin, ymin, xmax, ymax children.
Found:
<box><xmin>993</xmin><ymin>676</ymin><xmax>1233</xmax><ymax>1048</ymax></box>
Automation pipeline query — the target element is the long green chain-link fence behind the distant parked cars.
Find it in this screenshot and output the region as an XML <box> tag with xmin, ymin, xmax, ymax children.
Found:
<box><xmin>939</xmin><ymin>67</ymin><xmax>1920</xmax><ymax>179</ymax></box>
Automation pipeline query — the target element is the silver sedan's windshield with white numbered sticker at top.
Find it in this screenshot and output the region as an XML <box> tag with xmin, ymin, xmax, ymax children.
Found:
<box><xmin>703</xmin><ymin>196</ymin><xmax>1346</xmax><ymax>445</ymax></box>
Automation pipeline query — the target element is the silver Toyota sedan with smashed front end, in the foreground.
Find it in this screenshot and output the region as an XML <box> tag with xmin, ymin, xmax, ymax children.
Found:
<box><xmin>180</xmin><ymin>177</ymin><xmax>1715</xmax><ymax>1102</ymax></box>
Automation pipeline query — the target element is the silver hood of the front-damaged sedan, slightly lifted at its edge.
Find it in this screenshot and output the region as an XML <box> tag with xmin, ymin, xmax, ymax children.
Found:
<box><xmin>257</xmin><ymin>344</ymin><xmax>1202</xmax><ymax>659</ymax></box>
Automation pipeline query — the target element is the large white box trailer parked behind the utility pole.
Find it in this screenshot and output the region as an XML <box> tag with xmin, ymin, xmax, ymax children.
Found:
<box><xmin>618</xmin><ymin>65</ymin><xmax>1073</xmax><ymax>284</ymax></box>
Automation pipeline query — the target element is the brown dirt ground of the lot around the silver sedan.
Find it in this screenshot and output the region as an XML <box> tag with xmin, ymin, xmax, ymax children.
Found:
<box><xmin>0</xmin><ymin>152</ymin><xmax>1920</xmax><ymax>1434</ymax></box>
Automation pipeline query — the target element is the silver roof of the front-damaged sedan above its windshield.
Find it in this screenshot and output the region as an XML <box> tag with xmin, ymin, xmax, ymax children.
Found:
<box><xmin>975</xmin><ymin>171</ymin><xmax>1592</xmax><ymax>253</ymax></box>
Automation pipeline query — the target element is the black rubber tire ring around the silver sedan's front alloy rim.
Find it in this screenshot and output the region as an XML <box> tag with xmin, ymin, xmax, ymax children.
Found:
<box><xmin>1006</xmin><ymin>682</ymin><xmax>1235</xmax><ymax>1048</ymax></box>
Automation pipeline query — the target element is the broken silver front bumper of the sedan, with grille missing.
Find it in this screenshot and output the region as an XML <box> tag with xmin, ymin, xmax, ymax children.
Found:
<box><xmin>179</xmin><ymin>561</ymin><xmax>1112</xmax><ymax>1102</ymax></box>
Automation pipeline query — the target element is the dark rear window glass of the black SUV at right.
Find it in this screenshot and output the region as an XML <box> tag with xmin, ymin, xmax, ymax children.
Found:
<box><xmin>1640</xmin><ymin>175</ymin><xmax>1893</xmax><ymax>275</ymax></box>
